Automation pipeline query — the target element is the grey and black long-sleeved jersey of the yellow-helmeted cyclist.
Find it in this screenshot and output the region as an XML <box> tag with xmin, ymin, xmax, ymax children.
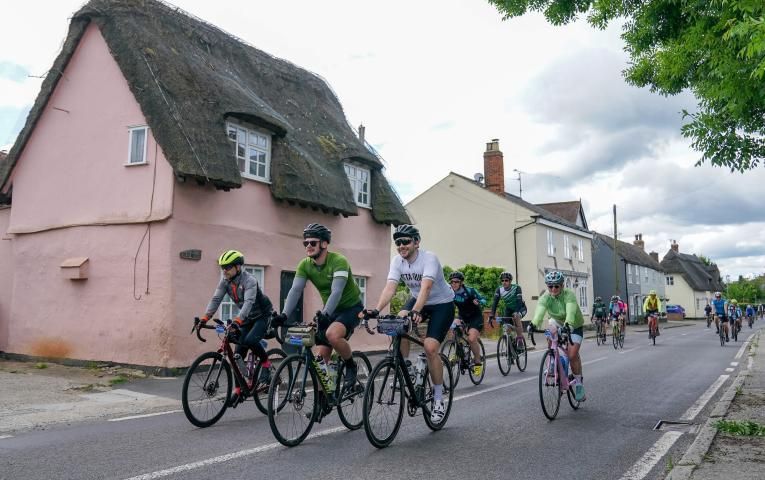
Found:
<box><xmin>205</xmin><ymin>270</ymin><xmax>273</xmax><ymax>324</ymax></box>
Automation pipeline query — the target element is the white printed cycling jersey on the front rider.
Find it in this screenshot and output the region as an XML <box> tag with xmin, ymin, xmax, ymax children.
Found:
<box><xmin>388</xmin><ymin>250</ymin><xmax>454</xmax><ymax>306</ymax></box>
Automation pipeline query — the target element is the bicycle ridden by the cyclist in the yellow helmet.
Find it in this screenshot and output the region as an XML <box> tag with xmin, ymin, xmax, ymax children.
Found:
<box><xmin>181</xmin><ymin>315</ymin><xmax>286</xmax><ymax>428</ymax></box>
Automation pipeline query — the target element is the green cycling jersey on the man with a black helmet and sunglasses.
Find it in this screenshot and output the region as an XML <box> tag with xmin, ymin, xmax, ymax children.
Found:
<box><xmin>295</xmin><ymin>252</ymin><xmax>361</xmax><ymax>310</ymax></box>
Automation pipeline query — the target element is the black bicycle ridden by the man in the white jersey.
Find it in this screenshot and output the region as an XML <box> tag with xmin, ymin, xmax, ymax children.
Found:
<box><xmin>363</xmin><ymin>314</ymin><xmax>454</xmax><ymax>448</ymax></box>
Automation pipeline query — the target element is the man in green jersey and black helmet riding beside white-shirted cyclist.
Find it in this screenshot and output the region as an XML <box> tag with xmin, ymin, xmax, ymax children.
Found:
<box><xmin>282</xmin><ymin>223</ymin><xmax>364</xmax><ymax>396</ymax></box>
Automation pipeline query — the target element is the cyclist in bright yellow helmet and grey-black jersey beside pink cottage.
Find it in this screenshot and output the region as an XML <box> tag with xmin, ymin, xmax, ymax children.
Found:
<box><xmin>200</xmin><ymin>250</ymin><xmax>273</xmax><ymax>408</ymax></box>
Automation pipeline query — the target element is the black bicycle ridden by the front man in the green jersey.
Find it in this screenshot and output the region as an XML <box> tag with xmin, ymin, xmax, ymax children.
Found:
<box><xmin>268</xmin><ymin>322</ymin><xmax>371</xmax><ymax>447</ymax></box>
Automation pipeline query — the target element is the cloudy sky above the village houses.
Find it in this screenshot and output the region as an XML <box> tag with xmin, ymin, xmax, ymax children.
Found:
<box><xmin>0</xmin><ymin>0</ymin><xmax>765</xmax><ymax>278</ymax></box>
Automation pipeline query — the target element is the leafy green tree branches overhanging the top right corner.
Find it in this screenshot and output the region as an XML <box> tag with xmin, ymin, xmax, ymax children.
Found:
<box><xmin>488</xmin><ymin>0</ymin><xmax>765</xmax><ymax>172</ymax></box>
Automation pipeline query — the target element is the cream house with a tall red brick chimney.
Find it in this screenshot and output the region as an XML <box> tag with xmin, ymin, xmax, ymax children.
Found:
<box><xmin>406</xmin><ymin>140</ymin><xmax>593</xmax><ymax>315</ymax></box>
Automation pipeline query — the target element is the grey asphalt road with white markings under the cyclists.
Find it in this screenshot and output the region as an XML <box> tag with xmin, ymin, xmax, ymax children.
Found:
<box><xmin>0</xmin><ymin>325</ymin><xmax>759</xmax><ymax>480</ymax></box>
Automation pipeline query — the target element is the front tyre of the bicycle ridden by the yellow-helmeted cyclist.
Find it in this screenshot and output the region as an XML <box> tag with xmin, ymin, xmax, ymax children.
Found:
<box><xmin>181</xmin><ymin>352</ymin><xmax>233</xmax><ymax>428</ymax></box>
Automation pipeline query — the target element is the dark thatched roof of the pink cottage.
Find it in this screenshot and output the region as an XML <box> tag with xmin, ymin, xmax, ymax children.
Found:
<box><xmin>0</xmin><ymin>0</ymin><xmax>409</xmax><ymax>224</ymax></box>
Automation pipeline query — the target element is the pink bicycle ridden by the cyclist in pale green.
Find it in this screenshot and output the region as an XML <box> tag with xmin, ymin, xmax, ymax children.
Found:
<box><xmin>529</xmin><ymin>321</ymin><xmax>581</xmax><ymax>420</ymax></box>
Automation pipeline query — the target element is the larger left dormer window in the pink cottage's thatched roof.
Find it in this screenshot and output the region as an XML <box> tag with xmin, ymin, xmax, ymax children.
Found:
<box><xmin>226</xmin><ymin>122</ymin><xmax>271</xmax><ymax>182</ymax></box>
